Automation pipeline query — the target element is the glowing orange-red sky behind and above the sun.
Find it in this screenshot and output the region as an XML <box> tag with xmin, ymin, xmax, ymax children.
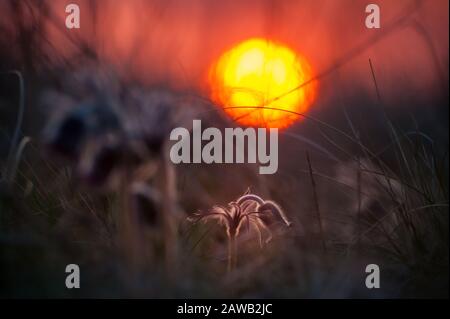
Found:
<box><xmin>3</xmin><ymin>0</ymin><xmax>448</xmax><ymax>106</ymax></box>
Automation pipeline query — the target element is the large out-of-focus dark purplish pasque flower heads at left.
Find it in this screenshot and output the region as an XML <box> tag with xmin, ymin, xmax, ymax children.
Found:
<box><xmin>43</xmin><ymin>69</ymin><xmax>197</xmax><ymax>186</ymax></box>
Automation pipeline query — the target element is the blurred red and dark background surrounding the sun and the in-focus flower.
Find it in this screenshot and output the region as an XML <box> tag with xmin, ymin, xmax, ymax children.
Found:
<box><xmin>0</xmin><ymin>0</ymin><xmax>449</xmax><ymax>298</ymax></box>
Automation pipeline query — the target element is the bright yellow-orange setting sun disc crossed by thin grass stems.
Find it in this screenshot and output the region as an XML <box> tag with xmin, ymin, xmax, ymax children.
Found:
<box><xmin>209</xmin><ymin>38</ymin><xmax>317</xmax><ymax>128</ymax></box>
